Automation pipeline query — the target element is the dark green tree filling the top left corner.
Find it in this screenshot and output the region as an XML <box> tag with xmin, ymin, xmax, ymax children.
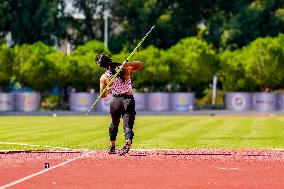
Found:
<box><xmin>0</xmin><ymin>0</ymin><xmax>67</xmax><ymax>45</ymax></box>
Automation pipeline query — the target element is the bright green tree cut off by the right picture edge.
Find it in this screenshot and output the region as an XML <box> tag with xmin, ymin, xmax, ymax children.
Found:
<box><xmin>244</xmin><ymin>35</ymin><xmax>284</xmax><ymax>90</ymax></box>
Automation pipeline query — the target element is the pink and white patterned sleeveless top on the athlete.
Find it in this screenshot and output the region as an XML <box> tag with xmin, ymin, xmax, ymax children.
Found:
<box><xmin>105</xmin><ymin>70</ymin><xmax>132</xmax><ymax>94</ymax></box>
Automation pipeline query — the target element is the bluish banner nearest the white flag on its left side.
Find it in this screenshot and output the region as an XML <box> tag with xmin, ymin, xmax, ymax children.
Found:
<box><xmin>171</xmin><ymin>92</ymin><xmax>194</xmax><ymax>111</ymax></box>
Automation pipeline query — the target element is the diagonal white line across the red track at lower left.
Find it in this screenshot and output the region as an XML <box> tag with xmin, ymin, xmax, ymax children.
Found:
<box><xmin>0</xmin><ymin>151</ymin><xmax>94</xmax><ymax>189</ymax></box>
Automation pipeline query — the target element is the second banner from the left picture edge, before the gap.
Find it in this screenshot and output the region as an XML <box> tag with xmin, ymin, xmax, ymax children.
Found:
<box><xmin>15</xmin><ymin>92</ymin><xmax>40</xmax><ymax>112</ymax></box>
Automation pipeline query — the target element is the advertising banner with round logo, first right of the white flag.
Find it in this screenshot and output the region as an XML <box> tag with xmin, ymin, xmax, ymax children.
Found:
<box><xmin>225</xmin><ymin>92</ymin><xmax>252</xmax><ymax>111</ymax></box>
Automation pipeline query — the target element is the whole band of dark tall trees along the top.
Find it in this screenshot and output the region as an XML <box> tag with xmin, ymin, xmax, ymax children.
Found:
<box><xmin>0</xmin><ymin>0</ymin><xmax>284</xmax><ymax>53</ymax></box>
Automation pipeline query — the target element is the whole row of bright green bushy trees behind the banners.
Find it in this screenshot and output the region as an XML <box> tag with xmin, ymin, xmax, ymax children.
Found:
<box><xmin>0</xmin><ymin>34</ymin><xmax>284</xmax><ymax>96</ymax></box>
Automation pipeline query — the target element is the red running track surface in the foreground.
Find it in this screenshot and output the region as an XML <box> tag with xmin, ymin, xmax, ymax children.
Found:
<box><xmin>0</xmin><ymin>150</ymin><xmax>284</xmax><ymax>189</ymax></box>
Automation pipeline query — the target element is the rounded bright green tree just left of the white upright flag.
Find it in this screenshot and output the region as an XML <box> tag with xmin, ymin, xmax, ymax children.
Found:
<box><xmin>165</xmin><ymin>37</ymin><xmax>219</xmax><ymax>97</ymax></box>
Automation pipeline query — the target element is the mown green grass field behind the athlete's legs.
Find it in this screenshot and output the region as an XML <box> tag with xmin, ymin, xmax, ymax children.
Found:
<box><xmin>0</xmin><ymin>116</ymin><xmax>284</xmax><ymax>150</ymax></box>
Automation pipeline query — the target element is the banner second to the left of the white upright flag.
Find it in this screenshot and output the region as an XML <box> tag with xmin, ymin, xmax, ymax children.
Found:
<box><xmin>147</xmin><ymin>92</ymin><xmax>170</xmax><ymax>111</ymax></box>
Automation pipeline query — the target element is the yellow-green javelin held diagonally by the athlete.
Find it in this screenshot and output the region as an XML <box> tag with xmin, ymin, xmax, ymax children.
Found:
<box><xmin>86</xmin><ymin>25</ymin><xmax>155</xmax><ymax>116</ymax></box>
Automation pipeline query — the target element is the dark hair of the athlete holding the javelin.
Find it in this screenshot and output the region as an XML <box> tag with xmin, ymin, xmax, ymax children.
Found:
<box><xmin>95</xmin><ymin>53</ymin><xmax>125</xmax><ymax>82</ymax></box>
